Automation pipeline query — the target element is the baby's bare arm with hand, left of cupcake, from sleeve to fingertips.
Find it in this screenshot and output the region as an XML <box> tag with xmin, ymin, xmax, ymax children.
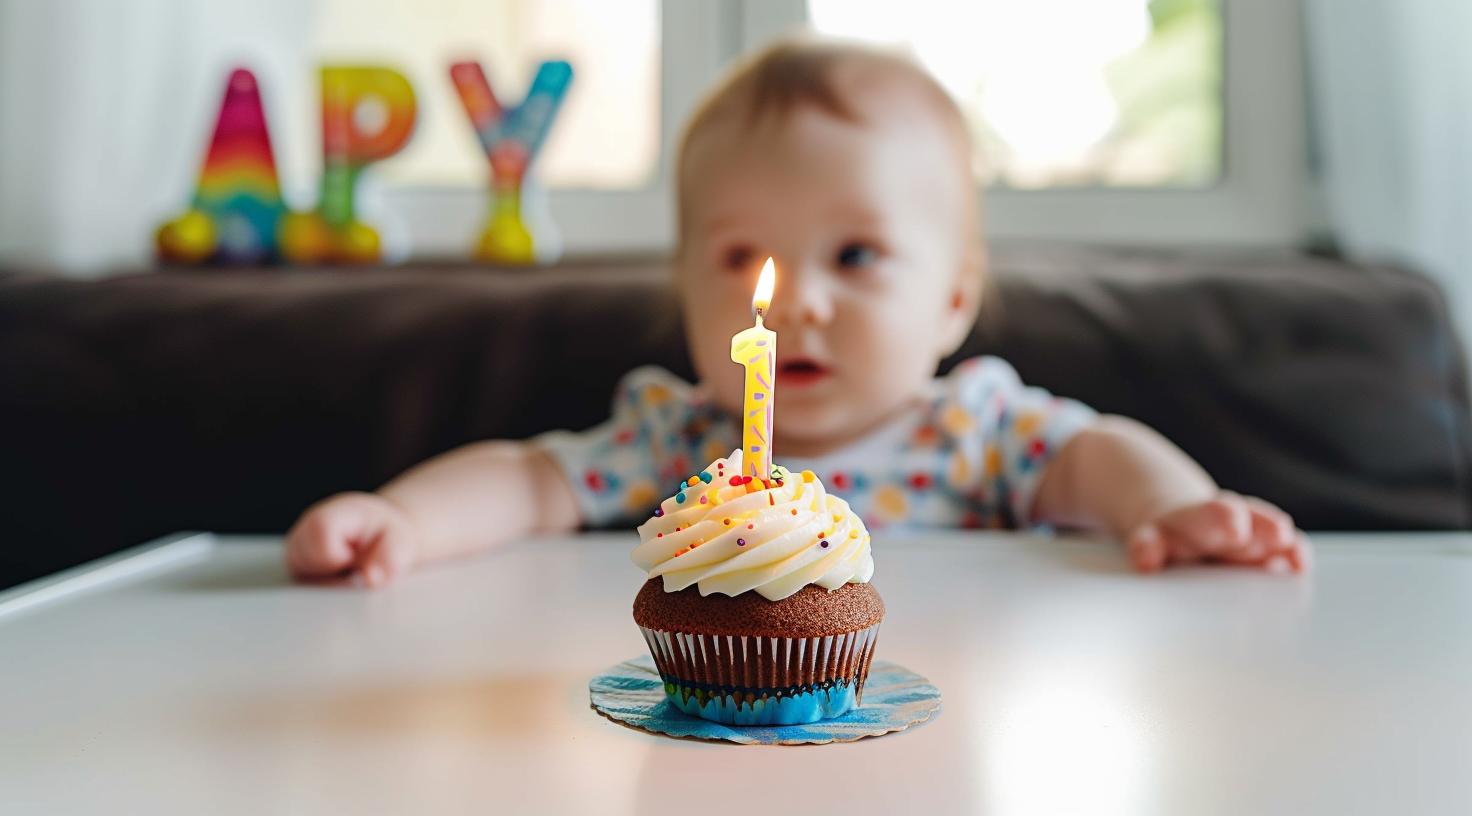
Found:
<box><xmin>286</xmin><ymin>442</ymin><xmax>578</xmax><ymax>586</ymax></box>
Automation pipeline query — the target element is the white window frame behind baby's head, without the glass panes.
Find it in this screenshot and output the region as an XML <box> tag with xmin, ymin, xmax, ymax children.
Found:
<box><xmin>394</xmin><ymin>0</ymin><xmax>1312</xmax><ymax>256</ymax></box>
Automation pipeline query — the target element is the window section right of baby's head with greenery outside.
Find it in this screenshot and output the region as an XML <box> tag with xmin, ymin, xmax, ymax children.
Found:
<box><xmin>765</xmin><ymin>0</ymin><xmax>1312</xmax><ymax>246</ymax></box>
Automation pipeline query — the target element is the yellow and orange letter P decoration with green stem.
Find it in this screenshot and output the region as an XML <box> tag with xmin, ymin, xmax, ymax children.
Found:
<box><xmin>280</xmin><ymin>66</ymin><xmax>415</xmax><ymax>264</ymax></box>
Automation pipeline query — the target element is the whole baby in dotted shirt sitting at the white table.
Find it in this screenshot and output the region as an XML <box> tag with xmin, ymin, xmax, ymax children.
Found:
<box><xmin>287</xmin><ymin>41</ymin><xmax>1309</xmax><ymax>586</ymax></box>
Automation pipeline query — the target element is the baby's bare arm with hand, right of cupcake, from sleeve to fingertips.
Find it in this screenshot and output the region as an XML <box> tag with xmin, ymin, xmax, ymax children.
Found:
<box><xmin>1033</xmin><ymin>417</ymin><xmax>1310</xmax><ymax>571</ymax></box>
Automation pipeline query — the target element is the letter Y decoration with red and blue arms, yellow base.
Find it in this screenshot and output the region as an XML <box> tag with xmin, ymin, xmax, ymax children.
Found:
<box><xmin>450</xmin><ymin>60</ymin><xmax>573</xmax><ymax>264</ymax></box>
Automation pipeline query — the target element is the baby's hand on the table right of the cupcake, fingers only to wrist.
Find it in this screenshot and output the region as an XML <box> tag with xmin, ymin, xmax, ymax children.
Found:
<box><xmin>1126</xmin><ymin>490</ymin><xmax>1312</xmax><ymax>573</ymax></box>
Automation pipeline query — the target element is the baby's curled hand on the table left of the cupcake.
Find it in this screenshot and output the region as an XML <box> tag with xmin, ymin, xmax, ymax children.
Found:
<box><xmin>286</xmin><ymin>493</ymin><xmax>415</xmax><ymax>586</ymax></box>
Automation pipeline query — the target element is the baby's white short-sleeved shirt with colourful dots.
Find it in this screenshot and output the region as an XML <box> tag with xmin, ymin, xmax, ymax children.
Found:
<box><xmin>537</xmin><ymin>356</ymin><xmax>1097</xmax><ymax>529</ymax></box>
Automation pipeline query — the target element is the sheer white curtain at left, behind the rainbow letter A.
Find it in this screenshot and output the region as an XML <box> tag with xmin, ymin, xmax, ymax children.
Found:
<box><xmin>0</xmin><ymin>0</ymin><xmax>316</xmax><ymax>275</ymax></box>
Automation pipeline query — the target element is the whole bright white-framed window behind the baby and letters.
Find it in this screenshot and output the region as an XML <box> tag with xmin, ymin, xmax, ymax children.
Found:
<box><xmin>295</xmin><ymin>0</ymin><xmax>1309</xmax><ymax>251</ymax></box>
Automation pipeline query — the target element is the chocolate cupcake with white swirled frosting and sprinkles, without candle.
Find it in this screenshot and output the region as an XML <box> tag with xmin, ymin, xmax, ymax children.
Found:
<box><xmin>633</xmin><ymin>451</ymin><xmax>885</xmax><ymax>725</ymax></box>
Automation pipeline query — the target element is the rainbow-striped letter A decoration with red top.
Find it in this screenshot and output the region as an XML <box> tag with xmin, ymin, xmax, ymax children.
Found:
<box><xmin>155</xmin><ymin>68</ymin><xmax>286</xmax><ymax>264</ymax></box>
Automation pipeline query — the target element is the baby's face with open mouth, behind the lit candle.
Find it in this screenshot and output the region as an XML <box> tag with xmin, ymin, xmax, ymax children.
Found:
<box><xmin>679</xmin><ymin>90</ymin><xmax>980</xmax><ymax>461</ymax></box>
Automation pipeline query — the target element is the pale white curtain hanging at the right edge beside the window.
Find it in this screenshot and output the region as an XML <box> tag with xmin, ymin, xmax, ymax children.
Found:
<box><xmin>1306</xmin><ymin>0</ymin><xmax>1472</xmax><ymax>348</ymax></box>
